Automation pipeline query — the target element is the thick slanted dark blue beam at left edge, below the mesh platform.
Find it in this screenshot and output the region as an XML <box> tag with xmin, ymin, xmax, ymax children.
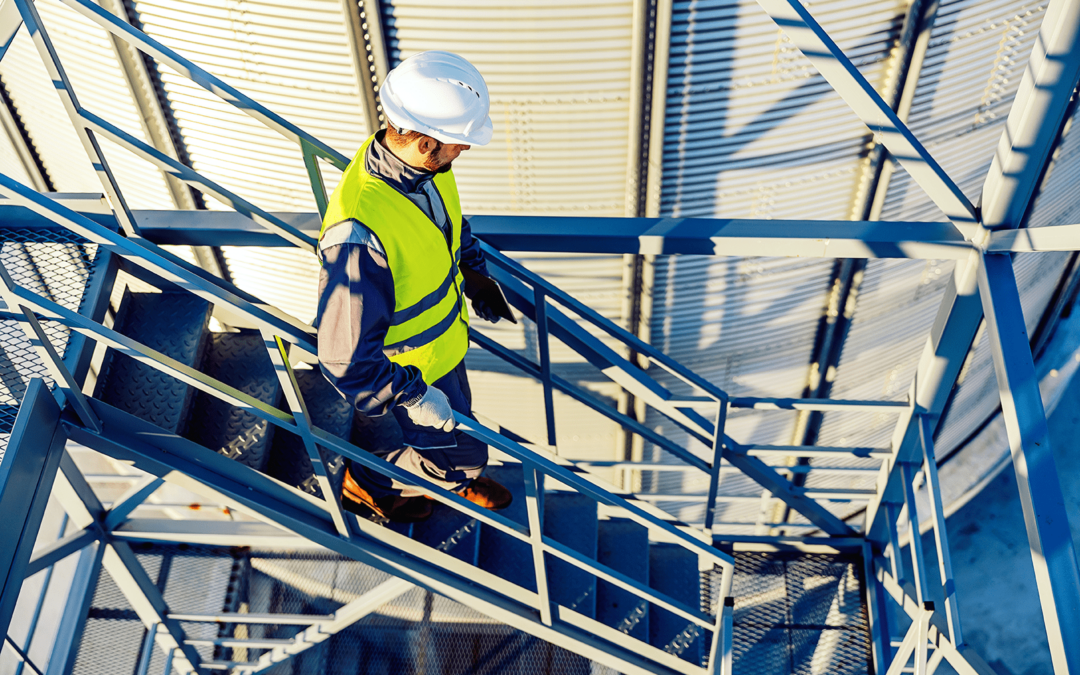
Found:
<box><xmin>0</xmin><ymin>378</ymin><xmax>67</xmax><ymax>636</ymax></box>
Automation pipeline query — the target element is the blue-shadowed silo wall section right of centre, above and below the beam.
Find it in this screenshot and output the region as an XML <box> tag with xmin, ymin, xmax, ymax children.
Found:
<box><xmin>645</xmin><ymin>0</ymin><xmax>905</xmax><ymax>531</ymax></box>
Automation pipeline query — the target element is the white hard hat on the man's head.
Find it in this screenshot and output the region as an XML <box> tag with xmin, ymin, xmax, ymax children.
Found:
<box><xmin>379</xmin><ymin>52</ymin><xmax>492</xmax><ymax>146</ymax></box>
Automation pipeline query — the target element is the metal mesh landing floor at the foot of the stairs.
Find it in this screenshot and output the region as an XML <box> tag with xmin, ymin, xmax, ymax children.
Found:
<box><xmin>703</xmin><ymin>552</ymin><xmax>872</xmax><ymax>675</ymax></box>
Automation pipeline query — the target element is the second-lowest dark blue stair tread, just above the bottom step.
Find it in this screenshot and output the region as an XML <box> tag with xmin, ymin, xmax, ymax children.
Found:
<box><xmin>596</xmin><ymin>518</ymin><xmax>649</xmax><ymax>640</ymax></box>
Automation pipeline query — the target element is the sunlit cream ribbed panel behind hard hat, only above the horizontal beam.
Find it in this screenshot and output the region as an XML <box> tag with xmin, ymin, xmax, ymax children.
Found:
<box><xmin>381</xmin><ymin>0</ymin><xmax>637</xmax><ymax>216</ymax></box>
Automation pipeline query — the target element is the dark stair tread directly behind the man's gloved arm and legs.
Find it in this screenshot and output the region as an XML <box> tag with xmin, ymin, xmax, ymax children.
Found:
<box><xmin>267</xmin><ymin>368</ymin><xmax>354</xmax><ymax>497</ymax></box>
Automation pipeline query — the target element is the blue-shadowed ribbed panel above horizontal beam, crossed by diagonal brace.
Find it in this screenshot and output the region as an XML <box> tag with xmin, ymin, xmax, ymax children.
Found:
<box><xmin>661</xmin><ymin>0</ymin><xmax>905</xmax><ymax>218</ymax></box>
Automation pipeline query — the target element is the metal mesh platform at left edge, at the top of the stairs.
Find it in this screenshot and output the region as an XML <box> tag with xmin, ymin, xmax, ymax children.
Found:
<box><xmin>0</xmin><ymin>229</ymin><xmax>97</xmax><ymax>456</ymax></box>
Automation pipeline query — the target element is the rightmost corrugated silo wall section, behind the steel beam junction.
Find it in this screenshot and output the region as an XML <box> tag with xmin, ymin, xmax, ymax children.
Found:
<box><xmin>808</xmin><ymin>2</ymin><xmax>1080</xmax><ymax>520</ymax></box>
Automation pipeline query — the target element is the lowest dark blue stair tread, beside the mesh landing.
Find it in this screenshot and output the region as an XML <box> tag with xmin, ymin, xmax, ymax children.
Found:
<box><xmin>649</xmin><ymin>543</ymin><xmax>703</xmax><ymax>665</ymax></box>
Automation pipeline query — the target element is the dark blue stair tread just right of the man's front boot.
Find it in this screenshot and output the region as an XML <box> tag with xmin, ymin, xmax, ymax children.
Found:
<box><xmin>478</xmin><ymin>464</ymin><xmax>537</xmax><ymax>591</ymax></box>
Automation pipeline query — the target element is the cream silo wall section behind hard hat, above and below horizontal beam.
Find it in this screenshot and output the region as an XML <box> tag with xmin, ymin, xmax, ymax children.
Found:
<box><xmin>381</xmin><ymin>0</ymin><xmax>638</xmax><ymax>459</ymax></box>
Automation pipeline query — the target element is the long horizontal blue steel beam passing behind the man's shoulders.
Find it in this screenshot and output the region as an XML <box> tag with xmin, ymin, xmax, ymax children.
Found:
<box><xmin>124</xmin><ymin>207</ymin><xmax>971</xmax><ymax>259</ymax></box>
